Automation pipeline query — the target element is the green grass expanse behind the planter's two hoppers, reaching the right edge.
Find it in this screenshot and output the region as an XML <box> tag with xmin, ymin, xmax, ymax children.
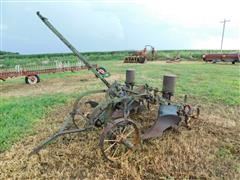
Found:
<box><xmin>101</xmin><ymin>62</ymin><xmax>240</xmax><ymax>105</ymax></box>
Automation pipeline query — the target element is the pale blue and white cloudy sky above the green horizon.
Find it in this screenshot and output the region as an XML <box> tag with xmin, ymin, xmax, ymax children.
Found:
<box><xmin>0</xmin><ymin>0</ymin><xmax>240</xmax><ymax>54</ymax></box>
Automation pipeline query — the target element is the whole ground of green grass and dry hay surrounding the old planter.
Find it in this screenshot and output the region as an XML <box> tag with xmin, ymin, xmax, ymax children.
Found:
<box><xmin>0</xmin><ymin>55</ymin><xmax>240</xmax><ymax>179</ymax></box>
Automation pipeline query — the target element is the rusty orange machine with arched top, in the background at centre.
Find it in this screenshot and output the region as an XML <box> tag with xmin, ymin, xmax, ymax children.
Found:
<box><xmin>124</xmin><ymin>45</ymin><xmax>157</xmax><ymax>63</ymax></box>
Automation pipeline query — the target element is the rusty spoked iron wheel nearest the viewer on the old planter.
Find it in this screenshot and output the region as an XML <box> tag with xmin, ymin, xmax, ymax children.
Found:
<box><xmin>99</xmin><ymin>118</ymin><xmax>141</xmax><ymax>162</ymax></box>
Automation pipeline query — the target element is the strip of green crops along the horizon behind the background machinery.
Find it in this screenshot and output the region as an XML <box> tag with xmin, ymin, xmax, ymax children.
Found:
<box><xmin>0</xmin><ymin>50</ymin><xmax>238</xmax><ymax>68</ymax></box>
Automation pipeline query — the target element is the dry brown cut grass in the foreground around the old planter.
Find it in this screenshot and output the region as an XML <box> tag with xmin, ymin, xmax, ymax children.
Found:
<box><xmin>0</xmin><ymin>101</ymin><xmax>240</xmax><ymax>179</ymax></box>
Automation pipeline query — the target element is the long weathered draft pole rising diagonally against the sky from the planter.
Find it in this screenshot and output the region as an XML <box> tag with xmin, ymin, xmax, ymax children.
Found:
<box><xmin>37</xmin><ymin>11</ymin><xmax>110</xmax><ymax>88</ymax></box>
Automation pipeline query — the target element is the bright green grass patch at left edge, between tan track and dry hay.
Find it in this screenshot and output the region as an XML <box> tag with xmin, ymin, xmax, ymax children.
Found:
<box><xmin>0</xmin><ymin>94</ymin><xmax>71</xmax><ymax>152</ymax></box>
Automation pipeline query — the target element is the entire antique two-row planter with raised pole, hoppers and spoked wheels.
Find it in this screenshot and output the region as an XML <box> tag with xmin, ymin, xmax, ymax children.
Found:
<box><xmin>30</xmin><ymin>12</ymin><xmax>200</xmax><ymax>161</ymax></box>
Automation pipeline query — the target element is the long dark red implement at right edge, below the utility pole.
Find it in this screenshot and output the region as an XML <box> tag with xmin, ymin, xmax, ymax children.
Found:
<box><xmin>202</xmin><ymin>53</ymin><xmax>240</xmax><ymax>64</ymax></box>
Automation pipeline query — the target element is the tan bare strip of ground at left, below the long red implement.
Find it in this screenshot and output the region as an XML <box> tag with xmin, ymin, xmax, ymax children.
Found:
<box><xmin>0</xmin><ymin>75</ymin><xmax>122</xmax><ymax>97</ymax></box>
